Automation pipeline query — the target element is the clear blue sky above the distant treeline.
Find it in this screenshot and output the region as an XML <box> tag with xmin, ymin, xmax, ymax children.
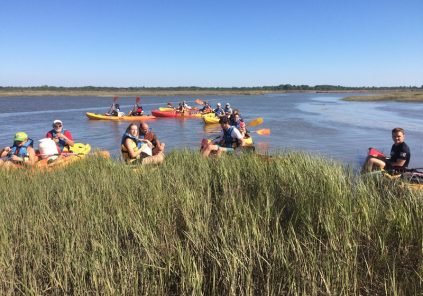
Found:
<box><xmin>0</xmin><ymin>0</ymin><xmax>423</xmax><ymax>87</ymax></box>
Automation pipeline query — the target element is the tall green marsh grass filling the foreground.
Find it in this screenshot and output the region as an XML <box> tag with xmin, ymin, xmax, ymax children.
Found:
<box><xmin>0</xmin><ymin>151</ymin><xmax>423</xmax><ymax>295</ymax></box>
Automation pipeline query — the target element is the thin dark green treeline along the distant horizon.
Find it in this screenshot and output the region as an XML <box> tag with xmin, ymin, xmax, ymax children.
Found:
<box><xmin>0</xmin><ymin>84</ymin><xmax>423</xmax><ymax>91</ymax></box>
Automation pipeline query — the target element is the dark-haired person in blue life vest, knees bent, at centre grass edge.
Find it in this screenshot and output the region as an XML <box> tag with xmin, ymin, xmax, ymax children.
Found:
<box><xmin>201</xmin><ymin>116</ymin><xmax>244</xmax><ymax>157</ymax></box>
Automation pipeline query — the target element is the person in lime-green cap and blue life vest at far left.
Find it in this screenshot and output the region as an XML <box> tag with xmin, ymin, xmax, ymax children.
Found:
<box><xmin>0</xmin><ymin>132</ymin><xmax>37</xmax><ymax>167</ymax></box>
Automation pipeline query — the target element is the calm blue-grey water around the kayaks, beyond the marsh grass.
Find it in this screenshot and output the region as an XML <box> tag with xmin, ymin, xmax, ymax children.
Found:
<box><xmin>0</xmin><ymin>93</ymin><xmax>423</xmax><ymax>167</ymax></box>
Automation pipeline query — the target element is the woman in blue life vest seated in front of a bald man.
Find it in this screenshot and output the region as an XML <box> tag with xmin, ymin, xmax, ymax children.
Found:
<box><xmin>121</xmin><ymin>123</ymin><xmax>164</xmax><ymax>164</ymax></box>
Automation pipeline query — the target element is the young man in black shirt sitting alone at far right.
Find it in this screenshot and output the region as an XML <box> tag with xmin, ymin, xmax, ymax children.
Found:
<box><xmin>363</xmin><ymin>127</ymin><xmax>411</xmax><ymax>172</ymax></box>
